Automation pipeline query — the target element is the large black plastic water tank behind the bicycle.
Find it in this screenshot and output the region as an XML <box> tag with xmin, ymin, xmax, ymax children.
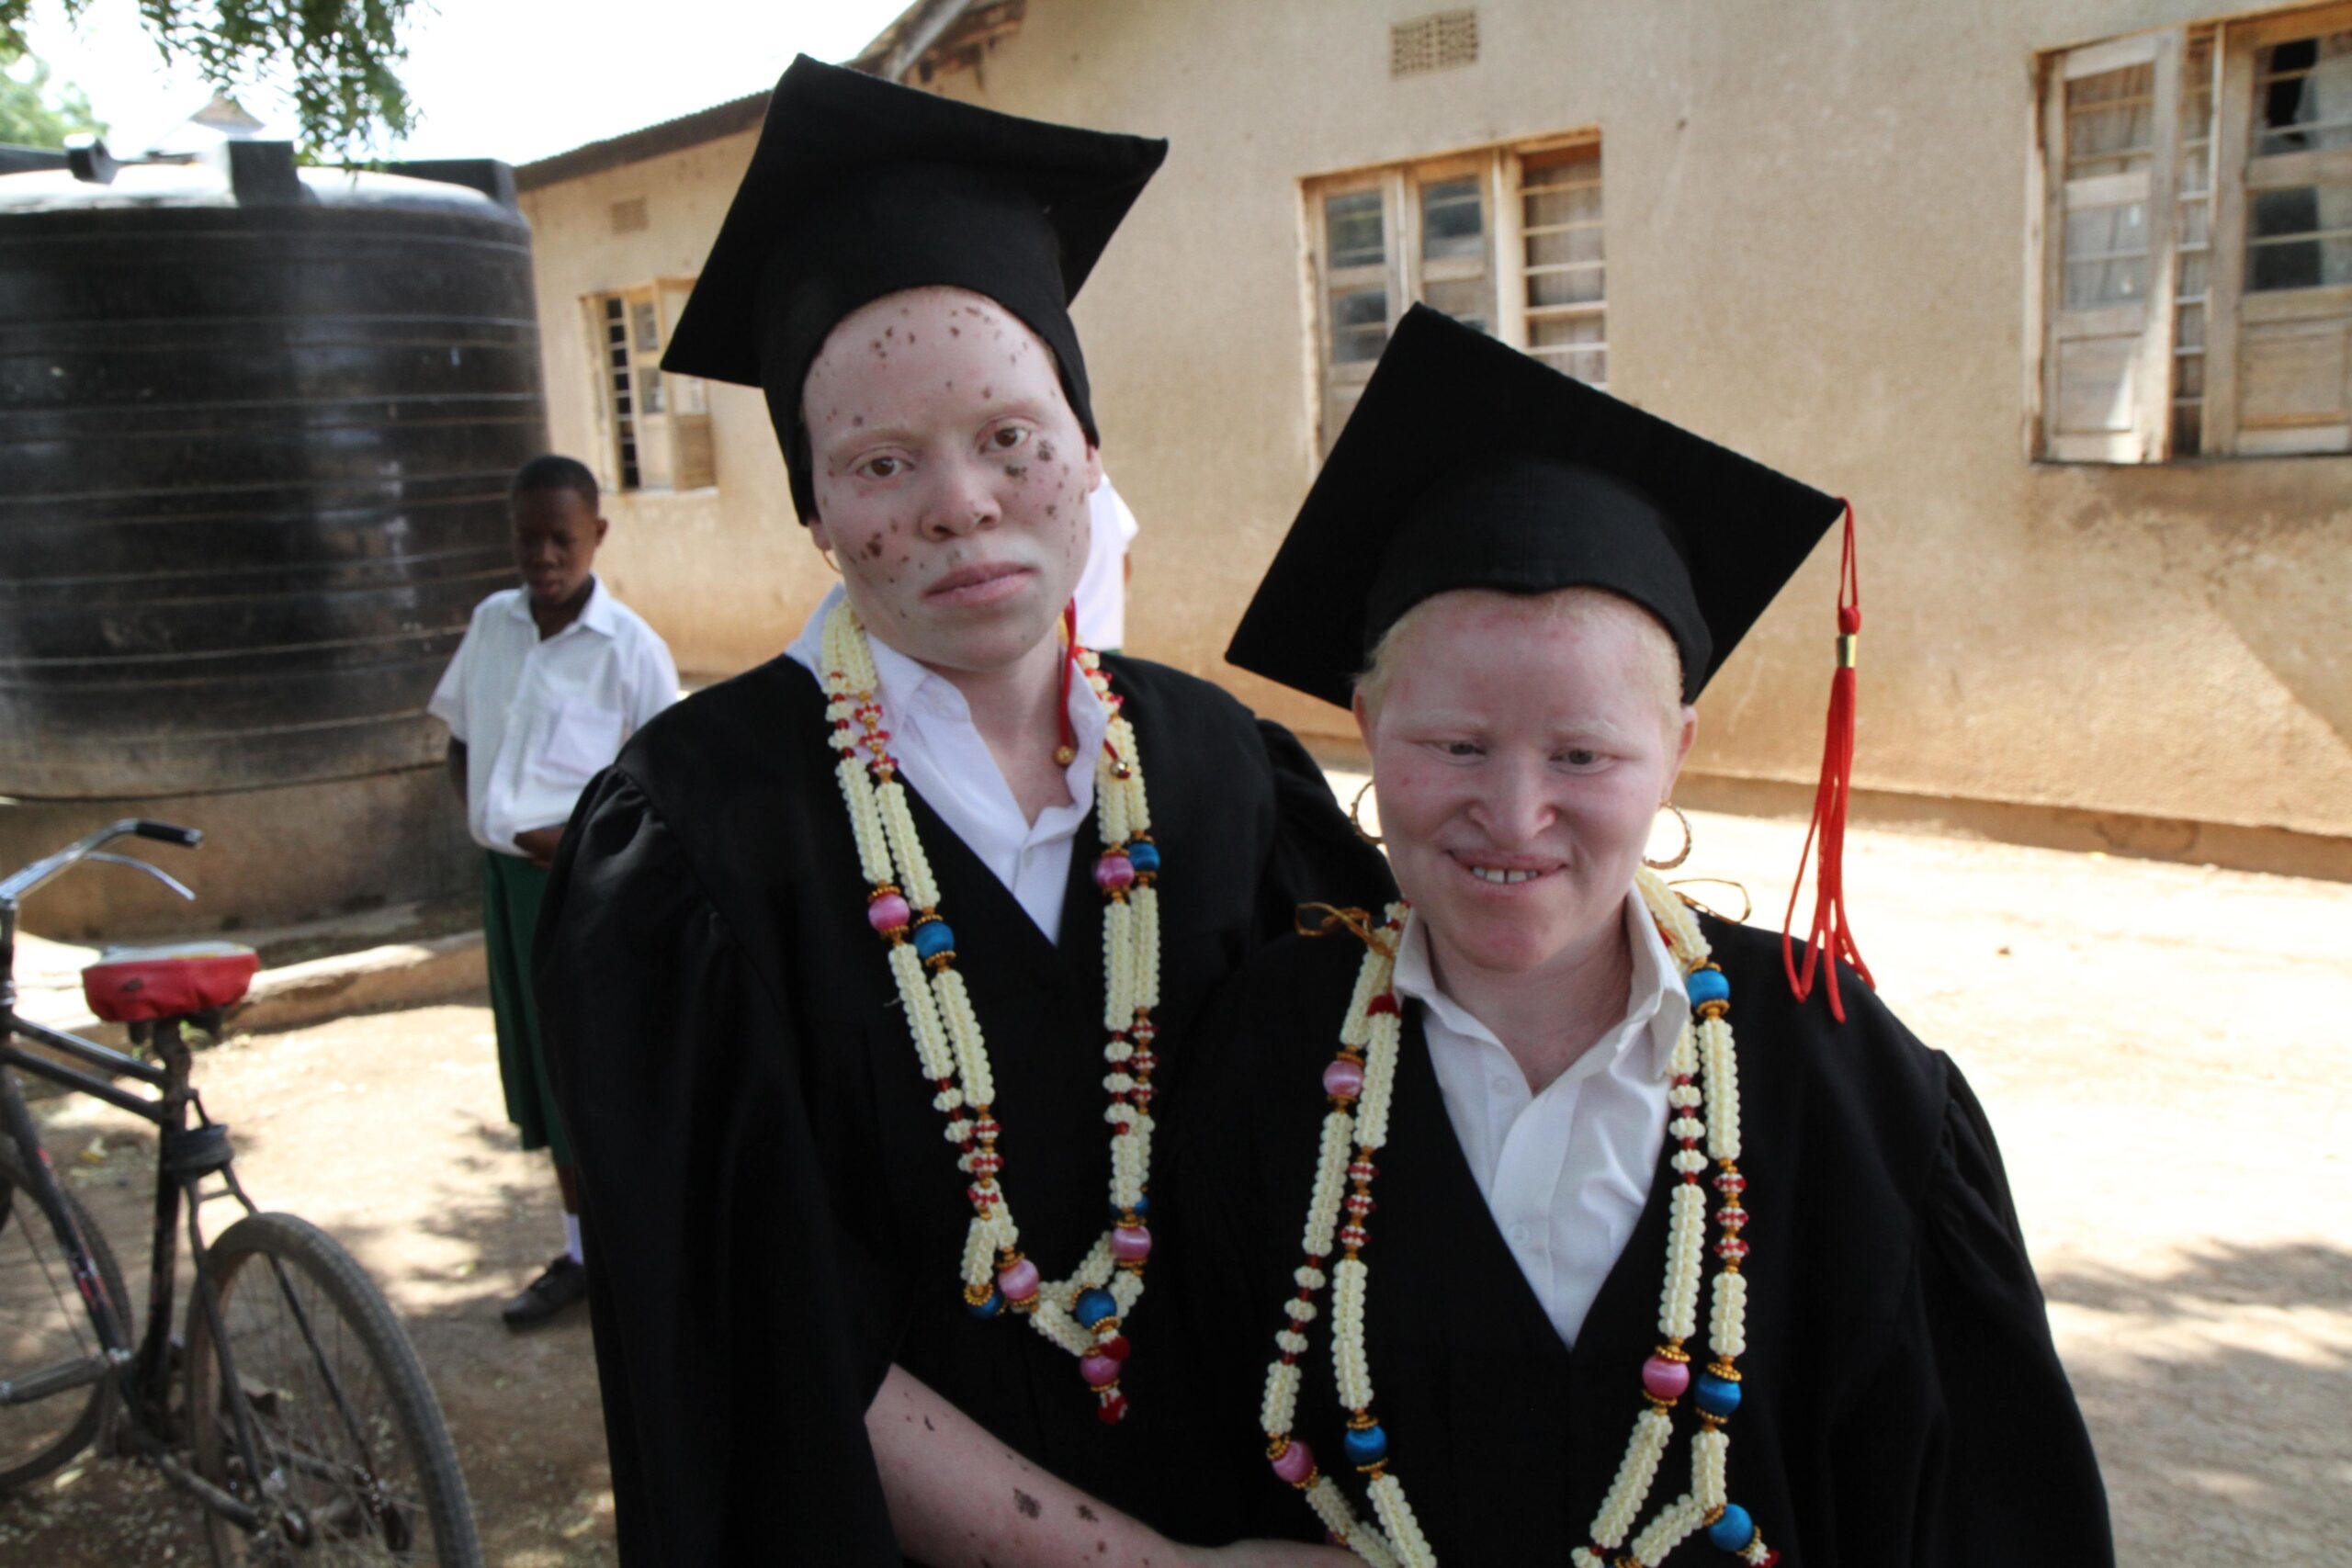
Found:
<box><xmin>0</xmin><ymin>143</ymin><xmax>546</xmax><ymax>802</ymax></box>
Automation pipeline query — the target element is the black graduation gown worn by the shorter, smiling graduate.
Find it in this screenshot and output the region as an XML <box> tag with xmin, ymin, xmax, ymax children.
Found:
<box><xmin>1162</xmin><ymin>919</ymin><xmax>2114</xmax><ymax>1568</ymax></box>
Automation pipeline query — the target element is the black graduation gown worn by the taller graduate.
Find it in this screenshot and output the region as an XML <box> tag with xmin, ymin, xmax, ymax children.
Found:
<box><xmin>537</xmin><ymin>659</ymin><xmax>1387</xmax><ymax>1568</ymax></box>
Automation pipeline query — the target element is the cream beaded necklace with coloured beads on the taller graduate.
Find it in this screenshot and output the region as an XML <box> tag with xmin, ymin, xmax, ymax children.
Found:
<box><xmin>823</xmin><ymin>600</ymin><xmax>1159</xmax><ymax>1425</ymax></box>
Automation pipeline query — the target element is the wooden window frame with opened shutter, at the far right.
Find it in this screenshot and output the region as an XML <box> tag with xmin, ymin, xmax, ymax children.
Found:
<box><xmin>2025</xmin><ymin>0</ymin><xmax>2352</xmax><ymax>463</ymax></box>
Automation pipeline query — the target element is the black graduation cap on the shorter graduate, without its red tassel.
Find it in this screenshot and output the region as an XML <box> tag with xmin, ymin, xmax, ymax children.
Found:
<box><xmin>1226</xmin><ymin>306</ymin><xmax>1844</xmax><ymax>707</ymax></box>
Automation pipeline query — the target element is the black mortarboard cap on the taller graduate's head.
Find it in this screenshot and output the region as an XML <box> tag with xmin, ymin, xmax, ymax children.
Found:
<box><xmin>661</xmin><ymin>54</ymin><xmax>1167</xmax><ymax>517</ymax></box>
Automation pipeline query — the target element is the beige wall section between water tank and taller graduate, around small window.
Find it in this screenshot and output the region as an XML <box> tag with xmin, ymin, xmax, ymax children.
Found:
<box><xmin>522</xmin><ymin>131</ymin><xmax>832</xmax><ymax>674</ymax></box>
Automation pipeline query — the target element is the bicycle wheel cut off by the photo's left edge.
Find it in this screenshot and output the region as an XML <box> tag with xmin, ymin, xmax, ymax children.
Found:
<box><xmin>0</xmin><ymin>1134</ymin><xmax>131</xmax><ymax>1493</ymax></box>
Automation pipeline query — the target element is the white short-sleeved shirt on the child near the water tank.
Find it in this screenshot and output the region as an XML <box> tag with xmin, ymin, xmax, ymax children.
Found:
<box><xmin>425</xmin><ymin>579</ymin><xmax>677</xmax><ymax>856</ymax></box>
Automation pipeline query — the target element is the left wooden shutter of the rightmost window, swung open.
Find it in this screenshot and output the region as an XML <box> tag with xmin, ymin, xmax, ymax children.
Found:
<box><xmin>2041</xmin><ymin>33</ymin><xmax>2180</xmax><ymax>463</ymax></box>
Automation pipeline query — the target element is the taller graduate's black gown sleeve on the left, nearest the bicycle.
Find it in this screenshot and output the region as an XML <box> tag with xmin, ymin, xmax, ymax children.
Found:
<box><xmin>537</xmin><ymin>769</ymin><xmax>900</xmax><ymax>1568</ymax></box>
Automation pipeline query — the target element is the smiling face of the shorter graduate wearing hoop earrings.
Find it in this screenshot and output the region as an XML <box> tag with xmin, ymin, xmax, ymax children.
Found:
<box><xmin>1357</xmin><ymin>592</ymin><xmax>1696</xmax><ymax>976</ymax></box>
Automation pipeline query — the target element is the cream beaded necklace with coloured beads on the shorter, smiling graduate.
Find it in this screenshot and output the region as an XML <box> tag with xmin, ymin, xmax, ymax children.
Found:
<box><xmin>1261</xmin><ymin>870</ymin><xmax>1781</xmax><ymax>1568</ymax></box>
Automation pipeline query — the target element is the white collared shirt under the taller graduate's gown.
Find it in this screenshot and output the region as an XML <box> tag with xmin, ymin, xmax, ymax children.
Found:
<box><xmin>786</xmin><ymin>583</ymin><xmax>1110</xmax><ymax>942</ymax></box>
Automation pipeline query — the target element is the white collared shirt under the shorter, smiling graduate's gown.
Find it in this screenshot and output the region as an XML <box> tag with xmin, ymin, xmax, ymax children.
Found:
<box><xmin>1395</xmin><ymin>898</ymin><xmax>1691</xmax><ymax>1349</ymax></box>
